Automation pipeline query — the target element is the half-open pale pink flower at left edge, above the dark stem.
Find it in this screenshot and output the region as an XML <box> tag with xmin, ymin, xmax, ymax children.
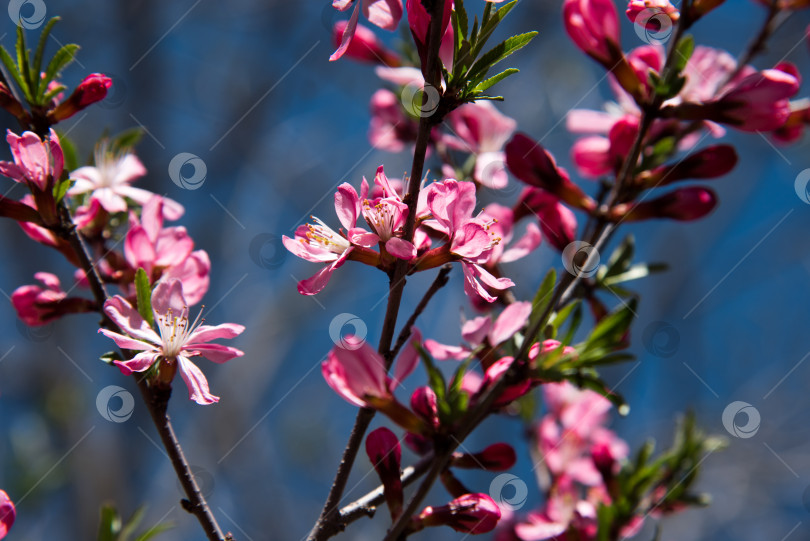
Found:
<box><xmin>0</xmin><ymin>130</ymin><xmax>65</xmax><ymax>192</ymax></box>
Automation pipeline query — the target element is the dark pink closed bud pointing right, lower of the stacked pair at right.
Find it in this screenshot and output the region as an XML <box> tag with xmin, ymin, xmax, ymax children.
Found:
<box><xmin>610</xmin><ymin>186</ymin><xmax>717</xmax><ymax>222</ymax></box>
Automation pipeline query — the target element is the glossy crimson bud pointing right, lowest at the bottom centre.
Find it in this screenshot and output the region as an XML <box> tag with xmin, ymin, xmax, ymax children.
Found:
<box><xmin>417</xmin><ymin>494</ymin><xmax>501</xmax><ymax>534</ymax></box>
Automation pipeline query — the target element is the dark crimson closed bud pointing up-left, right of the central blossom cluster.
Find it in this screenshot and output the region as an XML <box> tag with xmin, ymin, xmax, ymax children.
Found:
<box><xmin>505</xmin><ymin>133</ymin><xmax>596</xmax><ymax>211</ymax></box>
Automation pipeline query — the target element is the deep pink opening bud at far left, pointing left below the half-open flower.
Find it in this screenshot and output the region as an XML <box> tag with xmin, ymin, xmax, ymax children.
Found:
<box><xmin>11</xmin><ymin>272</ymin><xmax>97</xmax><ymax>327</ymax></box>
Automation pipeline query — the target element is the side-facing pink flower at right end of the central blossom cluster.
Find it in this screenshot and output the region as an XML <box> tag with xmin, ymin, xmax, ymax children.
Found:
<box><xmin>420</xmin><ymin>179</ymin><xmax>515</xmax><ymax>302</ymax></box>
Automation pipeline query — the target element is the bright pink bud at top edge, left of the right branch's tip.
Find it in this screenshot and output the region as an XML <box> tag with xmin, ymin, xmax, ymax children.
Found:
<box><xmin>563</xmin><ymin>0</ymin><xmax>621</xmax><ymax>68</ymax></box>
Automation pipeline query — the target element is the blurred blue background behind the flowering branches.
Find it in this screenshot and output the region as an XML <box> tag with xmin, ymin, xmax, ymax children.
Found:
<box><xmin>0</xmin><ymin>0</ymin><xmax>810</xmax><ymax>541</ymax></box>
